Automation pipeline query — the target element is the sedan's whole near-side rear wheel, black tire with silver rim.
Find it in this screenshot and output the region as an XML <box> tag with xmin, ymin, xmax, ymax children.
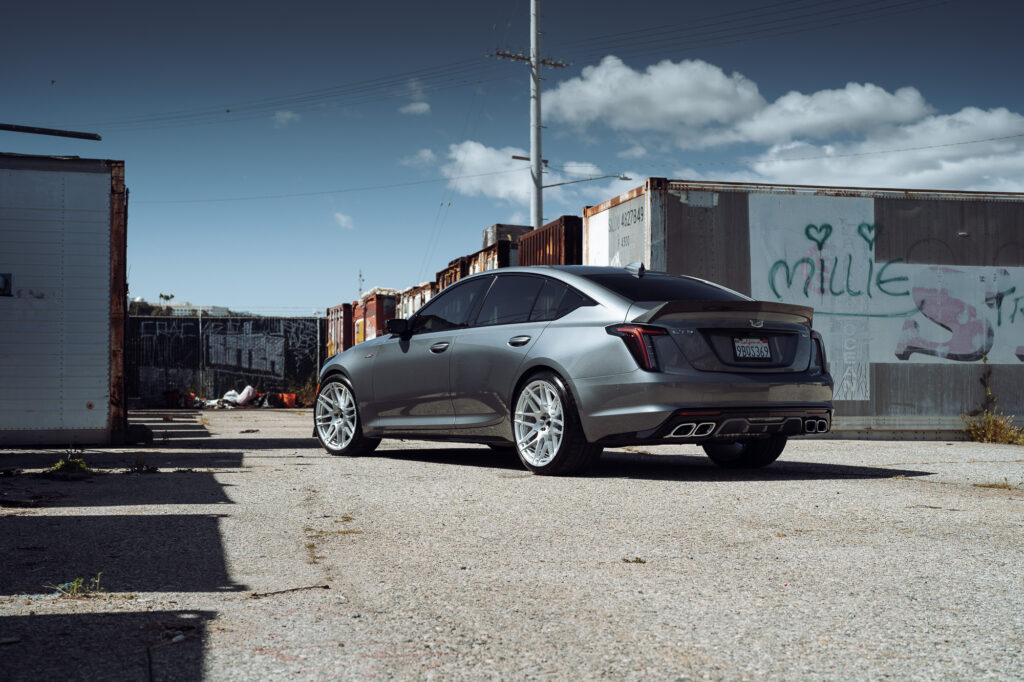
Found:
<box><xmin>512</xmin><ymin>371</ymin><xmax>601</xmax><ymax>475</ymax></box>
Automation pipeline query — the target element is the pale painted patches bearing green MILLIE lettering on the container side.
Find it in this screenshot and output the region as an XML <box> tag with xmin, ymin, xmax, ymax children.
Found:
<box><xmin>750</xmin><ymin>195</ymin><xmax>1024</xmax><ymax>400</ymax></box>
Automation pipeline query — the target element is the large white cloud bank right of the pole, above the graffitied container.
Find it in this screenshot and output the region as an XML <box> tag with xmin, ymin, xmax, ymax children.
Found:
<box><xmin>545</xmin><ymin>56</ymin><xmax>1024</xmax><ymax>189</ymax></box>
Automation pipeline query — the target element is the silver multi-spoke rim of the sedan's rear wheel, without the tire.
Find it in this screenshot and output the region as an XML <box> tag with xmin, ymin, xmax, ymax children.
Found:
<box><xmin>514</xmin><ymin>379</ymin><xmax>565</xmax><ymax>467</ymax></box>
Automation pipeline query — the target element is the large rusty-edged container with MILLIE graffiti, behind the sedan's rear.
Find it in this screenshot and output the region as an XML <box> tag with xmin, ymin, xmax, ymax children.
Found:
<box><xmin>583</xmin><ymin>178</ymin><xmax>1024</xmax><ymax>437</ymax></box>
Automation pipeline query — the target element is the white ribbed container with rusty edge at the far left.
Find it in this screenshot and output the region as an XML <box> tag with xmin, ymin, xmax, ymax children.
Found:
<box><xmin>0</xmin><ymin>154</ymin><xmax>128</xmax><ymax>446</ymax></box>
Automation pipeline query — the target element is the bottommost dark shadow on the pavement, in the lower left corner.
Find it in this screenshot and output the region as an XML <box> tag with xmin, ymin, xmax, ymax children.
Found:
<box><xmin>0</xmin><ymin>611</ymin><xmax>215</xmax><ymax>682</ymax></box>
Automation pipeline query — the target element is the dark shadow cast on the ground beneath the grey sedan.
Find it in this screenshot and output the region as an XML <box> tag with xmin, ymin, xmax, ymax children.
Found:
<box><xmin>372</xmin><ymin>444</ymin><xmax>934</xmax><ymax>481</ymax></box>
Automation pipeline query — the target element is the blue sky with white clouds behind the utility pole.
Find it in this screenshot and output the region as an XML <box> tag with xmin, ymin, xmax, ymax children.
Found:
<box><xmin>0</xmin><ymin>0</ymin><xmax>1024</xmax><ymax>314</ymax></box>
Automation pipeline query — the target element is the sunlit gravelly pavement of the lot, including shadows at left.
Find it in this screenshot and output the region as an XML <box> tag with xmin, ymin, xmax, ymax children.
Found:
<box><xmin>0</xmin><ymin>410</ymin><xmax>1024</xmax><ymax>680</ymax></box>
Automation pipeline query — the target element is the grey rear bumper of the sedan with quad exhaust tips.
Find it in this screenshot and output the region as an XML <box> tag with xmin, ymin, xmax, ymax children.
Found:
<box><xmin>573</xmin><ymin>370</ymin><xmax>833</xmax><ymax>444</ymax></box>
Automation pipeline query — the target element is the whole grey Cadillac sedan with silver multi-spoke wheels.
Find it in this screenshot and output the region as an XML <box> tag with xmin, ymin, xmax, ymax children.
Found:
<box><xmin>314</xmin><ymin>265</ymin><xmax>833</xmax><ymax>474</ymax></box>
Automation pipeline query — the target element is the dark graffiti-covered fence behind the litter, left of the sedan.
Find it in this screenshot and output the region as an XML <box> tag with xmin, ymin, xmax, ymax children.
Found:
<box><xmin>125</xmin><ymin>315</ymin><xmax>326</xmax><ymax>407</ymax></box>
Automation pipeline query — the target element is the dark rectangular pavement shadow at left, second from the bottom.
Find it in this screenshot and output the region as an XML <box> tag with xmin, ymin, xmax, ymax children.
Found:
<box><xmin>0</xmin><ymin>514</ymin><xmax>245</xmax><ymax>595</ymax></box>
